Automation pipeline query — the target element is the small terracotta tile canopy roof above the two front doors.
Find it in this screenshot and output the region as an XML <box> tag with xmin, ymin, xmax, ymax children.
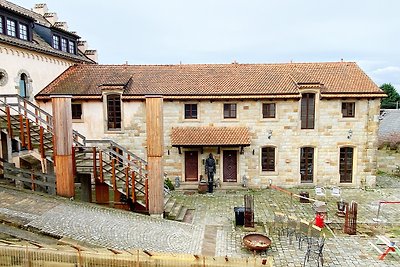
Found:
<box><xmin>171</xmin><ymin>126</ymin><xmax>250</xmax><ymax>146</ymax></box>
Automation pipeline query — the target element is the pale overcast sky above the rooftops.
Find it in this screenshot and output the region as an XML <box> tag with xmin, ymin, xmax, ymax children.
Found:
<box><xmin>11</xmin><ymin>0</ymin><xmax>400</xmax><ymax>91</ymax></box>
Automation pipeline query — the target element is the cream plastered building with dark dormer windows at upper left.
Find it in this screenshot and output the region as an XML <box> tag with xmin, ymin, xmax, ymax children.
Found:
<box><xmin>0</xmin><ymin>0</ymin><xmax>97</xmax><ymax>100</ymax></box>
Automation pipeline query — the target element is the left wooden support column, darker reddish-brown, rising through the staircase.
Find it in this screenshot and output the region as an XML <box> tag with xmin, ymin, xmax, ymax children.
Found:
<box><xmin>50</xmin><ymin>95</ymin><xmax>75</xmax><ymax>197</ymax></box>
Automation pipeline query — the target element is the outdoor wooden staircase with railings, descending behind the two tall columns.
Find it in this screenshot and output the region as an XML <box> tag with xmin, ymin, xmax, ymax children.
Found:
<box><xmin>0</xmin><ymin>95</ymin><xmax>148</xmax><ymax>213</ymax></box>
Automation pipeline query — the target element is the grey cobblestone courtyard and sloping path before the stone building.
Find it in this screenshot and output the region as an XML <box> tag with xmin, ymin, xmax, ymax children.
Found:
<box><xmin>0</xmin><ymin>176</ymin><xmax>400</xmax><ymax>266</ymax></box>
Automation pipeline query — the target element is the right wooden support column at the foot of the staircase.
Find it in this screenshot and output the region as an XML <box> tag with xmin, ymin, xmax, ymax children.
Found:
<box><xmin>146</xmin><ymin>96</ymin><xmax>164</xmax><ymax>216</ymax></box>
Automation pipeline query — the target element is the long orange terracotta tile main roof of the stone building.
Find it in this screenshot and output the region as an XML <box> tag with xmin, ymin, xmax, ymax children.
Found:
<box><xmin>38</xmin><ymin>62</ymin><xmax>382</xmax><ymax>99</ymax></box>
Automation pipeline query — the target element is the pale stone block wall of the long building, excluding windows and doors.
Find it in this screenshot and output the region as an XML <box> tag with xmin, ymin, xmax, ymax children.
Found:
<box><xmin>60</xmin><ymin>97</ymin><xmax>379</xmax><ymax>187</ymax></box>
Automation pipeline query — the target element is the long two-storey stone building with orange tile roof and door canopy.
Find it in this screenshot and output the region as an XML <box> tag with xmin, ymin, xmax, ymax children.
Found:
<box><xmin>36</xmin><ymin>62</ymin><xmax>385</xmax><ymax>188</ymax></box>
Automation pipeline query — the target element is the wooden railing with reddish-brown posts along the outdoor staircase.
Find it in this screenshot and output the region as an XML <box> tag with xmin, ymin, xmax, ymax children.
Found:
<box><xmin>0</xmin><ymin>95</ymin><xmax>148</xmax><ymax>210</ymax></box>
